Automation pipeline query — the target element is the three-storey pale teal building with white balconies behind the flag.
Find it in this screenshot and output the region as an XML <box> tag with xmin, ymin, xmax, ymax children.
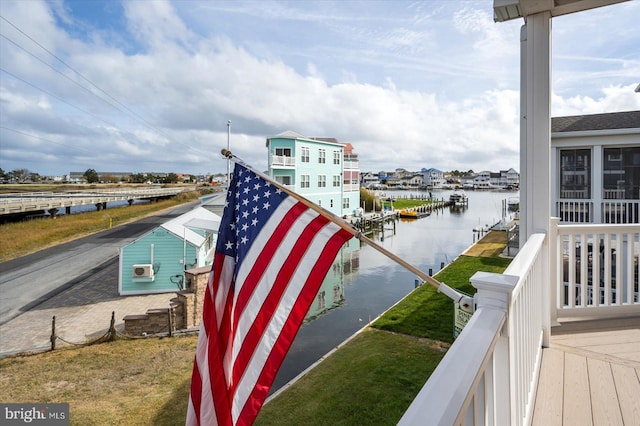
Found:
<box><xmin>267</xmin><ymin>131</ymin><xmax>360</xmax><ymax>216</ymax></box>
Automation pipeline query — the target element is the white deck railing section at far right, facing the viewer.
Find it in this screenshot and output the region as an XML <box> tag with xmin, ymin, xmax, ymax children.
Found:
<box><xmin>552</xmin><ymin>224</ymin><xmax>640</xmax><ymax>319</ymax></box>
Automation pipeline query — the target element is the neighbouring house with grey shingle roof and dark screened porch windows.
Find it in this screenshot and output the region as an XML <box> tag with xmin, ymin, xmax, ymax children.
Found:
<box><xmin>551</xmin><ymin>111</ymin><xmax>640</xmax><ymax>223</ymax></box>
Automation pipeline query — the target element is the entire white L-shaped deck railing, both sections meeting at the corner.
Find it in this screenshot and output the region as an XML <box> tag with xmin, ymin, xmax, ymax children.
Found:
<box><xmin>400</xmin><ymin>218</ymin><xmax>640</xmax><ymax>425</ymax></box>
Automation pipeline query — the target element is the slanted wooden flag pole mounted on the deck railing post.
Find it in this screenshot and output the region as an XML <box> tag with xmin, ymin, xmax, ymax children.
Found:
<box><xmin>221</xmin><ymin>149</ymin><xmax>473</xmax><ymax>312</ymax></box>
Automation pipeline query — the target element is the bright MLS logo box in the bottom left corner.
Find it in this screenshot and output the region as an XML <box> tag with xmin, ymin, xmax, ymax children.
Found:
<box><xmin>0</xmin><ymin>404</ymin><xmax>69</xmax><ymax>426</ymax></box>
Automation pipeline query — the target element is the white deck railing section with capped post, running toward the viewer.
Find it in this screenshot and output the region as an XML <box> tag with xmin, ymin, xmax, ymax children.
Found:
<box><xmin>399</xmin><ymin>234</ymin><xmax>549</xmax><ymax>425</ymax></box>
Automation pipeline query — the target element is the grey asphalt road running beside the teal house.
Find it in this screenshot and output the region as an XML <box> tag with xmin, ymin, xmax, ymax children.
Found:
<box><xmin>0</xmin><ymin>202</ymin><xmax>199</xmax><ymax>325</ymax></box>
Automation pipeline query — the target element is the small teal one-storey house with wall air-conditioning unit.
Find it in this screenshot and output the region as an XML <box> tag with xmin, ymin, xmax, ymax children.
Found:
<box><xmin>118</xmin><ymin>207</ymin><xmax>220</xmax><ymax>295</ymax></box>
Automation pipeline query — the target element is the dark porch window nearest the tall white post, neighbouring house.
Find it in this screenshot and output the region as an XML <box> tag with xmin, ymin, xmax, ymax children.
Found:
<box><xmin>560</xmin><ymin>149</ymin><xmax>591</xmax><ymax>199</ymax></box>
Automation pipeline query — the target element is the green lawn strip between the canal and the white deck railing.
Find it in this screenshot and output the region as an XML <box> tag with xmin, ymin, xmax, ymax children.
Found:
<box><xmin>256</xmin><ymin>256</ymin><xmax>510</xmax><ymax>425</ymax></box>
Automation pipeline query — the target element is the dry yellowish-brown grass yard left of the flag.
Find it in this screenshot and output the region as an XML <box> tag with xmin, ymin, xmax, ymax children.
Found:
<box><xmin>0</xmin><ymin>336</ymin><xmax>197</xmax><ymax>426</ymax></box>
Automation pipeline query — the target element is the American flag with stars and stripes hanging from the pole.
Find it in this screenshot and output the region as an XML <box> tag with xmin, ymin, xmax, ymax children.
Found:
<box><xmin>186</xmin><ymin>164</ymin><xmax>353</xmax><ymax>425</ymax></box>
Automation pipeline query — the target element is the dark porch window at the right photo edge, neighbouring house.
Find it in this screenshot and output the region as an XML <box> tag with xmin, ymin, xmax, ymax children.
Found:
<box><xmin>602</xmin><ymin>146</ymin><xmax>640</xmax><ymax>200</ymax></box>
